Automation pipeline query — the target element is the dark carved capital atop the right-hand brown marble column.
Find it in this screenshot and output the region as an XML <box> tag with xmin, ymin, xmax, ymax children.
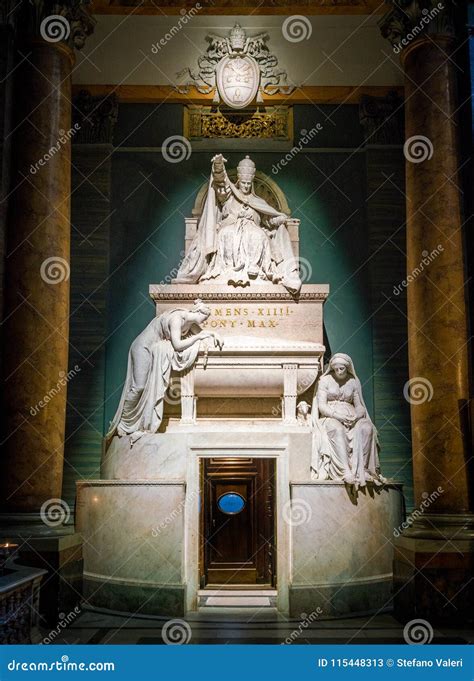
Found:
<box><xmin>379</xmin><ymin>0</ymin><xmax>456</xmax><ymax>54</ymax></box>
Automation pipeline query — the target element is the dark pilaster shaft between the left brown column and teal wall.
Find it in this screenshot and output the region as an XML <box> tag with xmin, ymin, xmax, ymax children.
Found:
<box><xmin>63</xmin><ymin>144</ymin><xmax>112</xmax><ymax>504</ymax></box>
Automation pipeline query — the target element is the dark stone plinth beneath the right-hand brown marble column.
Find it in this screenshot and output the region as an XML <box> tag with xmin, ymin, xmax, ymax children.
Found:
<box><xmin>393</xmin><ymin>514</ymin><xmax>474</xmax><ymax>625</ymax></box>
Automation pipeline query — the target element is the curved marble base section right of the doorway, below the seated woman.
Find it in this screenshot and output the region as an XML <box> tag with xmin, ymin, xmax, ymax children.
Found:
<box><xmin>289</xmin><ymin>482</ymin><xmax>403</xmax><ymax>618</ymax></box>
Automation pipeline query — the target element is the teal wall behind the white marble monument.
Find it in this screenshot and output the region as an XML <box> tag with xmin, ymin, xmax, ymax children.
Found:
<box><xmin>65</xmin><ymin>104</ymin><xmax>412</xmax><ymax>507</ymax></box>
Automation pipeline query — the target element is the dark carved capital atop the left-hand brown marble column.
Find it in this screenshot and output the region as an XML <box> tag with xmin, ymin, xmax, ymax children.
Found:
<box><xmin>15</xmin><ymin>0</ymin><xmax>96</xmax><ymax>50</ymax></box>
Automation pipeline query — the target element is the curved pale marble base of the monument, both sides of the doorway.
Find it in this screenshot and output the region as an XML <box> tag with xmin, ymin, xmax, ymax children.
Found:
<box><xmin>76</xmin><ymin>428</ymin><xmax>402</xmax><ymax>617</ymax></box>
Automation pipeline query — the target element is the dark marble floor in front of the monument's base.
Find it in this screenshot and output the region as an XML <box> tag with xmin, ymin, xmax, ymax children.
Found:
<box><xmin>41</xmin><ymin>596</ymin><xmax>474</xmax><ymax>645</ymax></box>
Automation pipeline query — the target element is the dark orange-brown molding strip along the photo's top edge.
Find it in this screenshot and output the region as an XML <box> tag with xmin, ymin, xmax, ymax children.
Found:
<box><xmin>93</xmin><ymin>0</ymin><xmax>383</xmax><ymax>16</ymax></box>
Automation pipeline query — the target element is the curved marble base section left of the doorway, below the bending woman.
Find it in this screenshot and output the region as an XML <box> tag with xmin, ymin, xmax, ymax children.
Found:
<box><xmin>76</xmin><ymin>480</ymin><xmax>186</xmax><ymax>615</ymax></box>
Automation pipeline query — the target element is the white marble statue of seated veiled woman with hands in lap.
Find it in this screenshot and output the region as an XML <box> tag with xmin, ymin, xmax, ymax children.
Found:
<box><xmin>311</xmin><ymin>352</ymin><xmax>386</xmax><ymax>488</ymax></box>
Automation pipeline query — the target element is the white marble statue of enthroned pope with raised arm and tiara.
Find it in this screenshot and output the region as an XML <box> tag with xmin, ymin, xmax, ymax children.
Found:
<box><xmin>176</xmin><ymin>154</ymin><xmax>301</xmax><ymax>293</ymax></box>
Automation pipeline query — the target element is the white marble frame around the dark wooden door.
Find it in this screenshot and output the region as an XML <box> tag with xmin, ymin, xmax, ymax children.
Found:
<box><xmin>183</xmin><ymin>438</ymin><xmax>291</xmax><ymax>614</ymax></box>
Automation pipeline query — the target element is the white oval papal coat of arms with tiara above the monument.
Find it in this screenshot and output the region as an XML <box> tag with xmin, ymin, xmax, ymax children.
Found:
<box><xmin>178</xmin><ymin>24</ymin><xmax>295</xmax><ymax>109</ymax></box>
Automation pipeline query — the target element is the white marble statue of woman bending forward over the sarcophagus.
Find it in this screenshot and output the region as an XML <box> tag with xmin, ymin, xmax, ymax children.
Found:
<box><xmin>106</xmin><ymin>300</ymin><xmax>222</xmax><ymax>444</ymax></box>
